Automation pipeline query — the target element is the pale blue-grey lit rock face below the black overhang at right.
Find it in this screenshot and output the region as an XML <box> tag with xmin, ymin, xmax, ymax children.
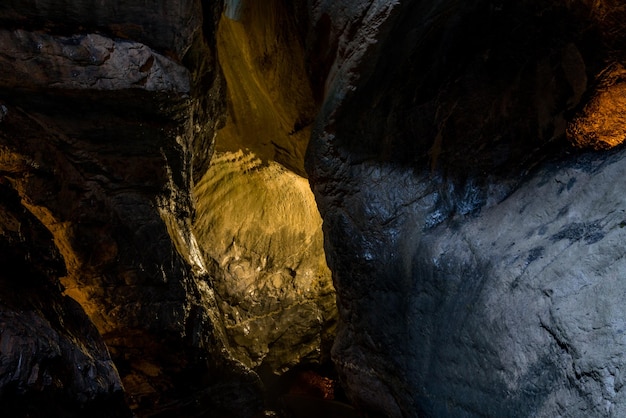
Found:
<box><xmin>326</xmin><ymin>149</ymin><xmax>626</xmax><ymax>417</ymax></box>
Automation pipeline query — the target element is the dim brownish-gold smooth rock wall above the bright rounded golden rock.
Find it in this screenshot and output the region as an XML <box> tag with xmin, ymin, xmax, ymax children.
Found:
<box><xmin>216</xmin><ymin>0</ymin><xmax>316</xmax><ymax>176</ymax></box>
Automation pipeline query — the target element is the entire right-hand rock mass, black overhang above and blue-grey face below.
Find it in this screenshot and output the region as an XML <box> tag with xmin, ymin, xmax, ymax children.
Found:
<box><xmin>307</xmin><ymin>0</ymin><xmax>626</xmax><ymax>417</ymax></box>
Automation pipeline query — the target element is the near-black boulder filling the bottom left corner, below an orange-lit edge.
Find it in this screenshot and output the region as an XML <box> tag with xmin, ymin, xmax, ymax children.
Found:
<box><xmin>0</xmin><ymin>184</ymin><xmax>130</xmax><ymax>417</ymax></box>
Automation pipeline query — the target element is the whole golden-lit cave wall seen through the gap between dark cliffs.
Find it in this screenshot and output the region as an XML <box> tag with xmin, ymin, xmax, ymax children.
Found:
<box><xmin>193</xmin><ymin>0</ymin><xmax>337</xmax><ymax>380</ymax></box>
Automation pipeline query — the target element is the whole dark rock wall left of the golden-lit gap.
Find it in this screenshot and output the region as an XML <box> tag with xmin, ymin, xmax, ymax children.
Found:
<box><xmin>0</xmin><ymin>1</ymin><xmax>263</xmax><ymax>417</ymax></box>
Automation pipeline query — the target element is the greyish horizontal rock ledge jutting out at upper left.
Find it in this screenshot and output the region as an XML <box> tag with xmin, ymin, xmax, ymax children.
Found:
<box><xmin>0</xmin><ymin>29</ymin><xmax>191</xmax><ymax>93</ymax></box>
